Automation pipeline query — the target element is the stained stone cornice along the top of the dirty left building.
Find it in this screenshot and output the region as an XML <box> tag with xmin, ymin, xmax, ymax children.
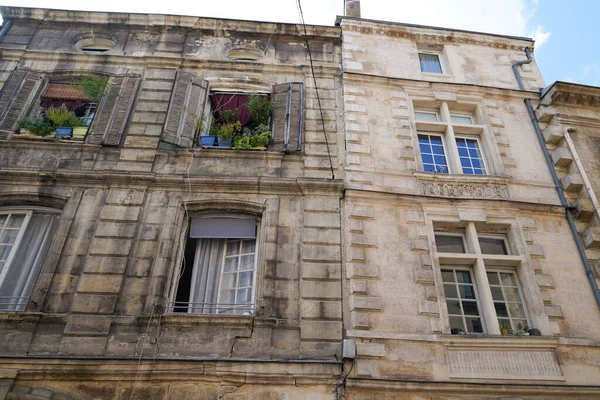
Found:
<box><xmin>0</xmin><ymin>6</ymin><xmax>340</xmax><ymax>41</ymax></box>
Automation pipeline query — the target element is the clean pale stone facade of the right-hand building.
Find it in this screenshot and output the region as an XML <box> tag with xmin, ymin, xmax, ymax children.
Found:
<box><xmin>338</xmin><ymin>17</ymin><xmax>600</xmax><ymax>399</ymax></box>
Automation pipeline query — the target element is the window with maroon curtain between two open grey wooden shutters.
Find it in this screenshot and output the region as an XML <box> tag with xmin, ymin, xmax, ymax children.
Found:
<box><xmin>162</xmin><ymin>71</ymin><xmax>304</xmax><ymax>153</ymax></box>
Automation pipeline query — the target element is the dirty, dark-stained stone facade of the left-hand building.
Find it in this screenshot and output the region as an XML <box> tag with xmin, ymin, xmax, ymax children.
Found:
<box><xmin>0</xmin><ymin>7</ymin><xmax>344</xmax><ymax>399</ymax></box>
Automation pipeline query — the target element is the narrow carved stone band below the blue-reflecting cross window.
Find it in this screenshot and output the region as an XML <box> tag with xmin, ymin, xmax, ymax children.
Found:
<box><xmin>421</xmin><ymin>181</ymin><xmax>510</xmax><ymax>200</ymax></box>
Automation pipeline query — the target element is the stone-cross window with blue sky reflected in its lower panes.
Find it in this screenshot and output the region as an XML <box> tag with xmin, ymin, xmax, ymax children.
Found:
<box><xmin>414</xmin><ymin>102</ymin><xmax>489</xmax><ymax>175</ymax></box>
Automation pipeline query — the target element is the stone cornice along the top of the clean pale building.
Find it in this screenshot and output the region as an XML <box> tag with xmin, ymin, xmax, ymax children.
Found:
<box><xmin>339</xmin><ymin>17</ymin><xmax>534</xmax><ymax>51</ymax></box>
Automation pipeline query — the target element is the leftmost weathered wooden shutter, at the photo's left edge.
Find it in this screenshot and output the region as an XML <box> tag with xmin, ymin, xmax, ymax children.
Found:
<box><xmin>0</xmin><ymin>69</ymin><xmax>46</xmax><ymax>140</ymax></box>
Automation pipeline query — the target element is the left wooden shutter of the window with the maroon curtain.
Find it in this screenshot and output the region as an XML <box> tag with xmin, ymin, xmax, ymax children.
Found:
<box><xmin>162</xmin><ymin>71</ymin><xmax>209</xmax><ymax>147</ymax></box>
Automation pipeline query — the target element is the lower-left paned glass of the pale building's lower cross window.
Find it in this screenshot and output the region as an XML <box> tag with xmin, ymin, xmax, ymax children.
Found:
<box><xmin>442</xmin><ymin>269</ymin><xmax>483</xmax><ymax>333</ymax></box>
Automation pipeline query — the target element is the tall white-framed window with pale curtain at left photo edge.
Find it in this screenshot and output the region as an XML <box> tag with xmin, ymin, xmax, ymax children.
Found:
<box><xmin>0</xmin><ymin>209</ymin><xmax>59</xmax><ymax>311</ymax></box>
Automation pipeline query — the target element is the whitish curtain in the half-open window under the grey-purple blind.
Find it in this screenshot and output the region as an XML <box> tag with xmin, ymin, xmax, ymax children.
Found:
<box><xmin>189</xmin><ymin>239</ymin><xmax>226</xmax><ymax>314</ymax></box>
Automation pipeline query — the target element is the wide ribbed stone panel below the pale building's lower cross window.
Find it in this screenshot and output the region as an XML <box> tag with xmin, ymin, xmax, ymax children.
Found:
<box><xmin>448</xmin><ymin>350</ymin><xmax>564</xmax><ymax>380</ymax></box>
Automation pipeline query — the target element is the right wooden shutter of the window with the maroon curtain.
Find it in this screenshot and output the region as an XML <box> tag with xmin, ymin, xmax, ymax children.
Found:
<box><xmin>271</xmin><ymin>82</ymin><xmax>304</xmax><ymax>153</ymax></box>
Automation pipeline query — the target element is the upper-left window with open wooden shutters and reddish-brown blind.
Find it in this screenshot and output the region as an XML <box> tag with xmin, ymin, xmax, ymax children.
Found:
<box><xmin>0</xmin><ymin>69</ymin><xmax>141</xmax><ymax>146</ymax></box>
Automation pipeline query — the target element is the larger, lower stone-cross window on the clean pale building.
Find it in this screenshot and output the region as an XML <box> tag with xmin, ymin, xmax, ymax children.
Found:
<box><xmin>435</xmin><ymin>223</ymin><xmax>528</xmax><ymax>333</ymax></box>
